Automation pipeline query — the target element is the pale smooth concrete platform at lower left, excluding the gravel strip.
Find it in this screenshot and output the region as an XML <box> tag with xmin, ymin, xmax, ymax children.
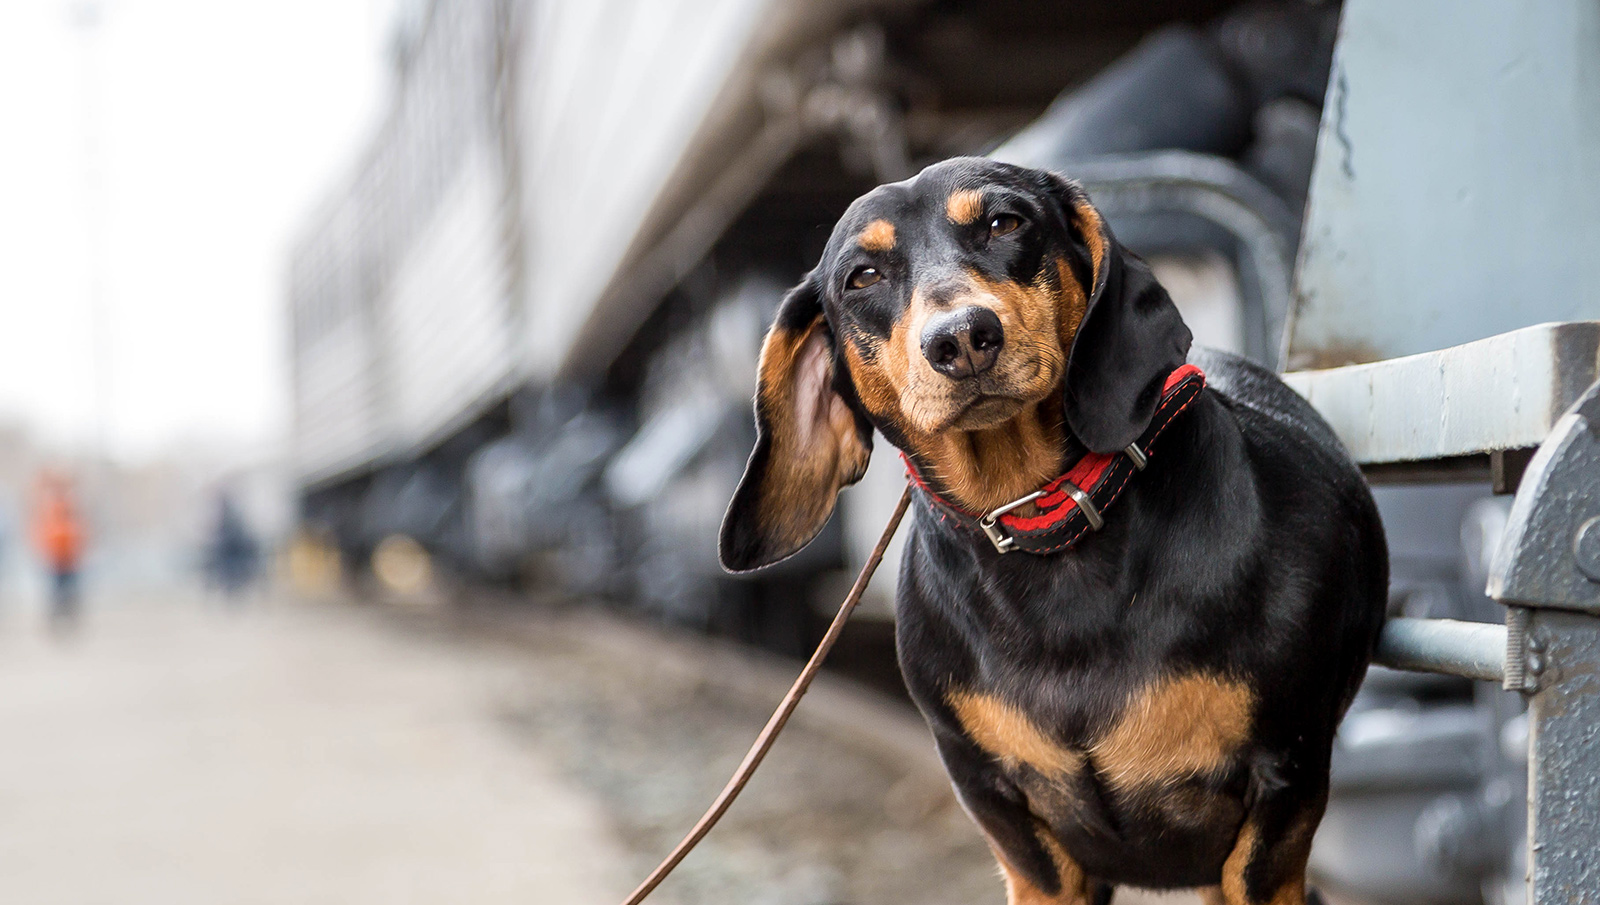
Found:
<box><xmin>0</xmin><ymin>600</ymin><xmax>627</xmax><ymax>905</ymax></box>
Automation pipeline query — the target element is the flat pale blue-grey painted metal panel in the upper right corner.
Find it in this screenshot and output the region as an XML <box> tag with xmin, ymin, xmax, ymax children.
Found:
<box><xmin>1288</xmin><ymin>0</ymin><xmax>1600</xmax><ymax>368</ymax></box>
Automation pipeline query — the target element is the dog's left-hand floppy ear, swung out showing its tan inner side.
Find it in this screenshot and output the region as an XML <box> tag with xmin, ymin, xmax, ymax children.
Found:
<box><xmin>718</xmin><ymin>272</ymin><xmax>872</xmax><ymax>572</ymax></box>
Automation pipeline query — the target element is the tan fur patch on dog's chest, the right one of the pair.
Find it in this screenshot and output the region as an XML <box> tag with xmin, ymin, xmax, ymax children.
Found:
<box><xmin>1090</xmin><ymin>675</ymin><xmax>1254</xmax><ymax>790</ymax></box>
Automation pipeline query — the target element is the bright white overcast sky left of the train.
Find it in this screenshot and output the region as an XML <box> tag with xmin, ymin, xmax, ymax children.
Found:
<box><xmin>0</xmin><ymin>0</ymin><xmax>394</xmax><ymax>460</ymax></box>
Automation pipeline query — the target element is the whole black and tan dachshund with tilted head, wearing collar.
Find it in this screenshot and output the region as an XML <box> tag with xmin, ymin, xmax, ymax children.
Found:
<box><xmin>722</xmin><ymin>158</ymin><xmax>1387</xmax><ymax>905</ymax></box>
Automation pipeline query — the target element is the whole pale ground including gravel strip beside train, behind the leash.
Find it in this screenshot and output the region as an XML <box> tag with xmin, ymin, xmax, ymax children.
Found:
<box><xmin>0</xmin><ymin>595</ymin><xmax>1195</xmax><ymax>905</ymax></box>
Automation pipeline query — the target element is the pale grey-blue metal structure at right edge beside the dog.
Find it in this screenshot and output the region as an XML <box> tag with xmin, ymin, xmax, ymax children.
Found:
<box><xmin>1285</xmin><ymin>0</ymin><xmax>1600</xmax><ymax>905</ymax></box>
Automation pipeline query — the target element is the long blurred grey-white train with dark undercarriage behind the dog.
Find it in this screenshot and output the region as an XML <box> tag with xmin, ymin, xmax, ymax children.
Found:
<box><xmin>290</xmin><ymin>0</ymin><xmax>1515</xmax><ymax>905</ymax></box>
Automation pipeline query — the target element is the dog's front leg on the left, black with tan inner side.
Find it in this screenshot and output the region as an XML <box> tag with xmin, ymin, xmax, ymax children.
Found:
<box><xmin>938</xmin><ymin>732</ymin><xmax>1110</xmax><ymax>905</ymax></box>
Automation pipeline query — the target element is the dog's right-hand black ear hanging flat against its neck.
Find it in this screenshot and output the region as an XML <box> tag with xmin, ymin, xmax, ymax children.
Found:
<box><xmin>1053</xmin><ymin>176</ymin><xmax>1192</xmax><ymax>453</ymax></box>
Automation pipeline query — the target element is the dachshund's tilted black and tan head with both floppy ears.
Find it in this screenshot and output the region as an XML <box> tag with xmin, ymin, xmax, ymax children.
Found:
<box><xmin>720</xmin><ymin>158</ymin><xmax>1189</xmax><ymax>571</ymax></box>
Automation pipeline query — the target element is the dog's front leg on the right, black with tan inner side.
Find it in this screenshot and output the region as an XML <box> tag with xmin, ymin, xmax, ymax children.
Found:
<box><xmin>1203</xmin><ymin>787</ymin><xmax>1328</xmax><ymax>905</ymax></box>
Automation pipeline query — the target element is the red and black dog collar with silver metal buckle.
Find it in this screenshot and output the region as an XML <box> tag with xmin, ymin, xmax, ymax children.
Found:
<box><xmin>901</xmin><ymin>365</ymin><xmax>1205</xmax><ymax>555</ymax></box>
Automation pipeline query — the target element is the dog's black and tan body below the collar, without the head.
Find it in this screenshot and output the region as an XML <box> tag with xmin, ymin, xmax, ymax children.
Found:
<box><xmin>898</xmin><ymin>345</ymin><xmax>1386</xmax><ymax>902</ymax></box>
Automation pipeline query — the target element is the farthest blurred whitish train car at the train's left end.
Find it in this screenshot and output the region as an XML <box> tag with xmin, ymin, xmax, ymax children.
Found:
<box><xmin>290</xmin><ymin>3</ymin><xmax>525</xmax><ymax>575</ymax></box>
